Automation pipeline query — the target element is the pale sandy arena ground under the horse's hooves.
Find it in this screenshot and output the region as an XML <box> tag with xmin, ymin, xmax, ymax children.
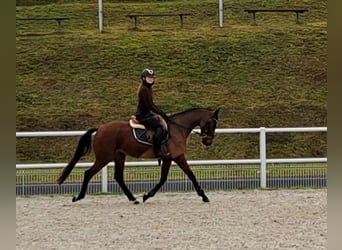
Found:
<box><xmin>16</xmin><ymin>189</ymin><xmax>327</xmax><ymax>250</ymax></box>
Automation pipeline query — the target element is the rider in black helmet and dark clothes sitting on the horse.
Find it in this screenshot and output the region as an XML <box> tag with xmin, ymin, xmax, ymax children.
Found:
<box><xmin>136</xmin><ymin>69</ymin><xmax>168</xmax><ymax>159</ymax></box>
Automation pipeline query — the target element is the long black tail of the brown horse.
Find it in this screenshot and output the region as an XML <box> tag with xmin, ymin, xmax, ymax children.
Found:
<box><xmin>57</xmin><ymin>128</ymin><xmax>97</xmax><ymax>184</ymax></box>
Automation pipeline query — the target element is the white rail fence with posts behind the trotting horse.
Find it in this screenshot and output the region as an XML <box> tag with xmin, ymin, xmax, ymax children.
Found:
<box><xmin>16</xmin><ymin>127</ymin><xmax>327</xmax><ymax>192</ymax></box>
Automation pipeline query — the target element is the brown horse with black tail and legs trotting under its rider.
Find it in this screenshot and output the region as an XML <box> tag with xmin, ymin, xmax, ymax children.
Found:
<box><xmin>57</xmin><ymin>108</ymin><xmax>219</xmax><ymax>204</ymax></box>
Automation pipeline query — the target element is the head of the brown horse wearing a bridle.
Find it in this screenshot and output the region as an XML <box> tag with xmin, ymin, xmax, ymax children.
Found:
<box><xmin>200</xmin><ymin>108</ymin><xmax>220</xmax><ymax>146</ymax></box>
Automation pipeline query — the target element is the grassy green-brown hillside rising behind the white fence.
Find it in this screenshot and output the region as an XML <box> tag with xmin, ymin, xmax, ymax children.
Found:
<box><xmin>16</xmin><ymin>0</ymin><xmax>327</xmax><ymax>163</ymax></box>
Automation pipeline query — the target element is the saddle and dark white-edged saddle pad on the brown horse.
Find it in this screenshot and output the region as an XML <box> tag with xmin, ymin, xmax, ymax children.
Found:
<box><xmin>129</xmin><ymin>115</ymin><xmax>169</xmax><ymax>146</ymax></box>
